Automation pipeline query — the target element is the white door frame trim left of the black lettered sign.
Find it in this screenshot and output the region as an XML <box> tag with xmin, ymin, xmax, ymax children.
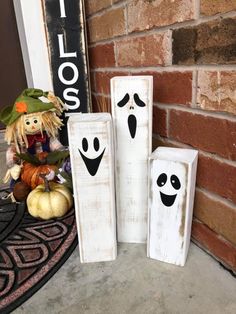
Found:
<box><xmin>14</xmin><ymin>0</ymin><xmax>53</xmax><ymax>90</ymax></box>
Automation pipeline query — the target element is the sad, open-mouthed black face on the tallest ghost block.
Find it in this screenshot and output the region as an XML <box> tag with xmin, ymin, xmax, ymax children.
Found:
<box><xmin>117</xmin><ymin>93</ymin><xmax>146</xmax><ymax>138</ymax></box>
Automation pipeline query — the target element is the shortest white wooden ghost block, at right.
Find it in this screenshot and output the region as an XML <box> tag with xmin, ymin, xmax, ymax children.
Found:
<box><xmin>147</xmin><ymin>147</ymin><xmax>198</xmax><ymax>266</ymax></box>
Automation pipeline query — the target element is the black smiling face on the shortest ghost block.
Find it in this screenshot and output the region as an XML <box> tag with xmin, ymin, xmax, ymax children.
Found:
<box><xmin>157</xmin><ymin>173</ymin><xmax>181</xmax><ymax>207</ymax></box>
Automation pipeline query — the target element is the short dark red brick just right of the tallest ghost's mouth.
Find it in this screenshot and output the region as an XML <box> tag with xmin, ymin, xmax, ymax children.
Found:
<box><xmin>153</xmin><ymin>106</ymin><xmax>167</xmax><ymax>136</ymax></box>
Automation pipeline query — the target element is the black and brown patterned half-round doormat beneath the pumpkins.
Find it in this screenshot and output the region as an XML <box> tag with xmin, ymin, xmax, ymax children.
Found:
<box><xmin>0</xmin><ymin>190</ymin><xmax>78</xmax><ymax>314</ymax></box>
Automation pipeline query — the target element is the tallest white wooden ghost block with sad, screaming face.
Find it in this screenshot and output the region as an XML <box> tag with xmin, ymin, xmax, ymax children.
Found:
<box><xmin>111</xmin><ymin>76</ymin><xmax>153</xmax><ymax>243</ymax></box>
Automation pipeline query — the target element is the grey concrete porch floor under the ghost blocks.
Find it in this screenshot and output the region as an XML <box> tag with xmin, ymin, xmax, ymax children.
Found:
<box><xmin>14</xmin><ymin>243</ymin><xmax>236</xmax><ymax>314</ymax></box>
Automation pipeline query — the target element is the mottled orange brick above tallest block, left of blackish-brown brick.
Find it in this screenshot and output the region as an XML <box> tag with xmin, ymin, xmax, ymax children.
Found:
<box><xmin>116</xmin><ymin>33</ymin><xmax>171</xmax><ymax>67</ymax></box>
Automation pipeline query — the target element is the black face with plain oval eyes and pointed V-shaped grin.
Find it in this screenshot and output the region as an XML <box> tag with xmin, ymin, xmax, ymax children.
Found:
<box><xmin>79</xmin><ymin>137</ymin><xmax>106</xmax><ymax>176</ymax></box>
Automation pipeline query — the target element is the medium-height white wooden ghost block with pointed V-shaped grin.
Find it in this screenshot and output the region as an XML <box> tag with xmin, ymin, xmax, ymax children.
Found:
<box><xmin>68</xmin><ymin>113</ymin><xmax>117</xmax><ymax>263</ymax></box>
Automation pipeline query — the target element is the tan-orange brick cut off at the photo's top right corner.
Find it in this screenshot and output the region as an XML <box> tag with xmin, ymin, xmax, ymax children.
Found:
<box><xmin>201</xmin><ymin>0</ymin><xmax>236</xmax><ymax>15</ymax></box>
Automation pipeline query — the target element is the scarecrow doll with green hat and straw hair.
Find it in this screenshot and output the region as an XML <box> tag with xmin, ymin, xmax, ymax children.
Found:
<box><xmin>0</xmin><ymin>88</ymin><xmax>68</xmax><ymax>195</ymax></box>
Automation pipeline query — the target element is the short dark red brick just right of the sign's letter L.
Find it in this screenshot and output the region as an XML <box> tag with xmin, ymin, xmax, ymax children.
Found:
<box><xmin>89</xmin><ymin>43</ymin><xmax>115</xmax><ymax>69</ymax></box>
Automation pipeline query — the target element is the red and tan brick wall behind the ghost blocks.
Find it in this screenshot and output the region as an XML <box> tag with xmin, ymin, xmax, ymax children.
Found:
<box><xmin>86</xmin><ymin>0</ymin><xmax>236</xmax><ymax>271</ymax></box>
